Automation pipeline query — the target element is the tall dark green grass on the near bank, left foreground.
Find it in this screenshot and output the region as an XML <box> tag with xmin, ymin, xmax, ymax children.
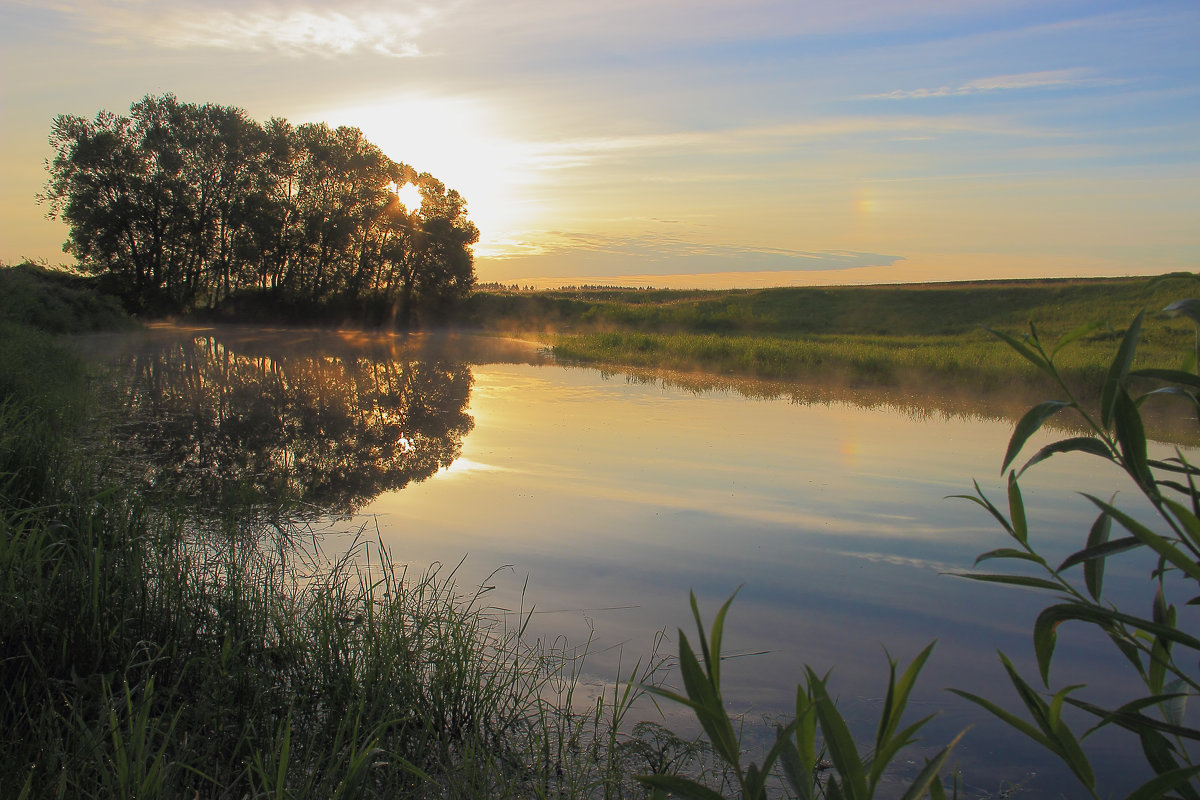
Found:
<box><xmin>0</xmin><ymin>323</ymin><xmax>696</xmax><ymax>798</ymax></box>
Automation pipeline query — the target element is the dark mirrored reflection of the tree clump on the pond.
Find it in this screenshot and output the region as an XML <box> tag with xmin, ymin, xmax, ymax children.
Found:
<box><xmin>92</xmin><ymin>332</ymin><xmax>474</xmax><ymax>515</ymax></box>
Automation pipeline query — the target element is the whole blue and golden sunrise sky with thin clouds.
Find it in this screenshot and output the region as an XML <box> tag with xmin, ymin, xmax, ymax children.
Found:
<box><xmin>0</xmin><ymin>0</ymin><xmax>1200</xmax><ymax>288</ymax></box>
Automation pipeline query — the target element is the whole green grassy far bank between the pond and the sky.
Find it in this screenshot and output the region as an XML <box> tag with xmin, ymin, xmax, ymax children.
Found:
<box><xmin>468</xmin><ymin>277</ymin><xmax>1195</xmax><ymax>386</ymax></box>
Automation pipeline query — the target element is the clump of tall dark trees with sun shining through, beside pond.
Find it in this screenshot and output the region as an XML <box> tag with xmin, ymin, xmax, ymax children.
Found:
<box><xmin>43</xmin><ymin>95</ymin><xmax>479</xmax><ymax>326</ymax></box>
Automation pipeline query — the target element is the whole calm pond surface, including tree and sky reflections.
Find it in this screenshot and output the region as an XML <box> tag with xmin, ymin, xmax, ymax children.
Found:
<box><xmin>84</xmin><ymin>326</ymin><xmax>1194</xmax><ymax>796</ymax></box>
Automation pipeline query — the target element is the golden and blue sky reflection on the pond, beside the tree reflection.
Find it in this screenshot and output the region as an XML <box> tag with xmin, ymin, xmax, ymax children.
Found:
<box><xmin>364</xmin><ymin>365</ymin><xmax>1190</xmax><ymax>796</ymax></box>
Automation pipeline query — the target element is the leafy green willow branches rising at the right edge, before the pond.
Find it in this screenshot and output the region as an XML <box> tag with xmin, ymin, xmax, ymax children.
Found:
<box><xmin>955</xmin><ymin>298</ymin><xmax>1200</xmax><ymax>799</ymax></box>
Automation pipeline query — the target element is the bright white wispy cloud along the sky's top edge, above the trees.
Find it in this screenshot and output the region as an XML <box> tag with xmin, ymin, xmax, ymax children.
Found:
<box><xmin>32</xmin><ymin>0</ymin><xmax>434</xmax><ymax>58</ymax></box>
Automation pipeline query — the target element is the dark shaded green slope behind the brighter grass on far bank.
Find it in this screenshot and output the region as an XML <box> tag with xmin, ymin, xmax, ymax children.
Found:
<box><xmin>463</xmin><ymin>276</ymin><xmax>1192</xmax><ymax>341</ymax></box>
